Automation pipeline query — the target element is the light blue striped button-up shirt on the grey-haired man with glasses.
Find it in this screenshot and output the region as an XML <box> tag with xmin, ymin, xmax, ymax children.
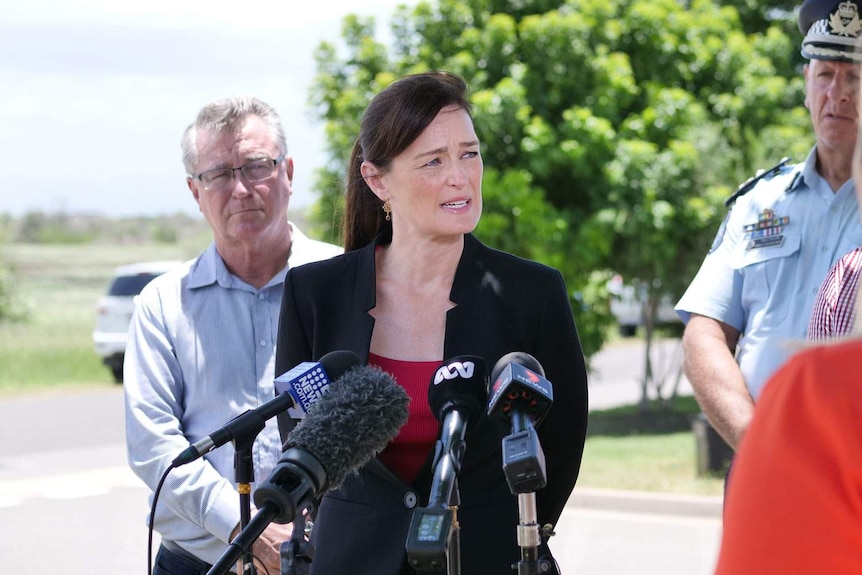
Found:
<box><xmin>124</xmin><ymin>226</ymin><xmax>342</xmax><ymax>563</ymax></box>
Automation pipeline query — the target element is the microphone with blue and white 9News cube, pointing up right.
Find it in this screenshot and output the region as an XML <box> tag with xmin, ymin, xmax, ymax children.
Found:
<box><xmin>172</xmin><ymin>350</ymin><xmax>362</xmax><ymax>467</ymax></box>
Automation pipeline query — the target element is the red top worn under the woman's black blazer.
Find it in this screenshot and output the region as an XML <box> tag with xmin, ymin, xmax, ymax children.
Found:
<box><xmin>368</xmin><ymin>353</ymin><xmax>442</xmax><ymax>483</ymax></box>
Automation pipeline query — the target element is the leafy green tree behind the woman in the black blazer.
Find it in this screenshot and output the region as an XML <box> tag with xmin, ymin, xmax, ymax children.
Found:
<box><xmin>310</xmin><ymin>0</ymin><xmax>813</xmax><ymax>397</ymax></box>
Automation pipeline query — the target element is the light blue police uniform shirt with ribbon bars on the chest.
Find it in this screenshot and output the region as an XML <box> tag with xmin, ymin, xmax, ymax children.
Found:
<box><xmin>675</xmin><ymin>148</ymin><xmax>862</xmax><ymax>399</ymax></box>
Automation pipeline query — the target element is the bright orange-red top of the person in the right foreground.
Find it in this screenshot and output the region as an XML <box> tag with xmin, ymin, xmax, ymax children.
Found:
<box><xmin>716</xmin><ymin>339</ymin><xmax>862</xmax><ymax>575</ymax></box>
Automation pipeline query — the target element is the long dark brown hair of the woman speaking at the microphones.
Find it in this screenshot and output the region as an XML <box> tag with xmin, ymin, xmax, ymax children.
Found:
<box><xmin>344</xmin><ymin>71</ymin><xmax>471</xmax><ymax>251</ymax></box>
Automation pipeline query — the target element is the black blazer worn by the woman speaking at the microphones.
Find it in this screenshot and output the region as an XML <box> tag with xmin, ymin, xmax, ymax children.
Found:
<box><xmin>276</xmin><ymin>234</ymin><xmax>588</xmax><ymax>575</ymax></box>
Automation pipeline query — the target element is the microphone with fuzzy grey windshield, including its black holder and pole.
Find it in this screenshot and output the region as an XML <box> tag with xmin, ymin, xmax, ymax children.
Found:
<box><xmin>207</xmin><ymin>366</ymin><xmax>410</xmax><ymax>575</ymax></box>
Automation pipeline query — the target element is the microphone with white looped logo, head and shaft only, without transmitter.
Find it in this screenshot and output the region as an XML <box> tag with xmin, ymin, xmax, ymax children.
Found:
<box><xmin>428</xmin><ymin>355</ymin><xmax>488</xmax><ymax>507</ymax></box>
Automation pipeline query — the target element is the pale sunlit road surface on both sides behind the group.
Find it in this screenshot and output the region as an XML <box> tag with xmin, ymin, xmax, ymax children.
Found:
<box><xmin>0</xmin><ymin>342</ymin><xmax>721</xmax><ymax>575</ymax></box>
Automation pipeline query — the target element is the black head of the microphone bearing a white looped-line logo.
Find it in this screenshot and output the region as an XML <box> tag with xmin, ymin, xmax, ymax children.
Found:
<box><xmin>428</xmin><ymin>355</ymin><xmax>488</xmax><ymax>426</ymax></box>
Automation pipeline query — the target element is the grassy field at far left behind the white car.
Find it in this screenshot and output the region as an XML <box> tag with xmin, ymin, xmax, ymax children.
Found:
<box><xmin>0</xmin><ymin>240</ymin><xmax>205</xmax><ymax>396</ymax></box>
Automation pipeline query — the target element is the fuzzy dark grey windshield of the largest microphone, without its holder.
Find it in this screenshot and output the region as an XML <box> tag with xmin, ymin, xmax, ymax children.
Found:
<box><xmin>285</xmin><ymin>366</ymin><xmax>410</xmax><ymax>495</ymax></box>
